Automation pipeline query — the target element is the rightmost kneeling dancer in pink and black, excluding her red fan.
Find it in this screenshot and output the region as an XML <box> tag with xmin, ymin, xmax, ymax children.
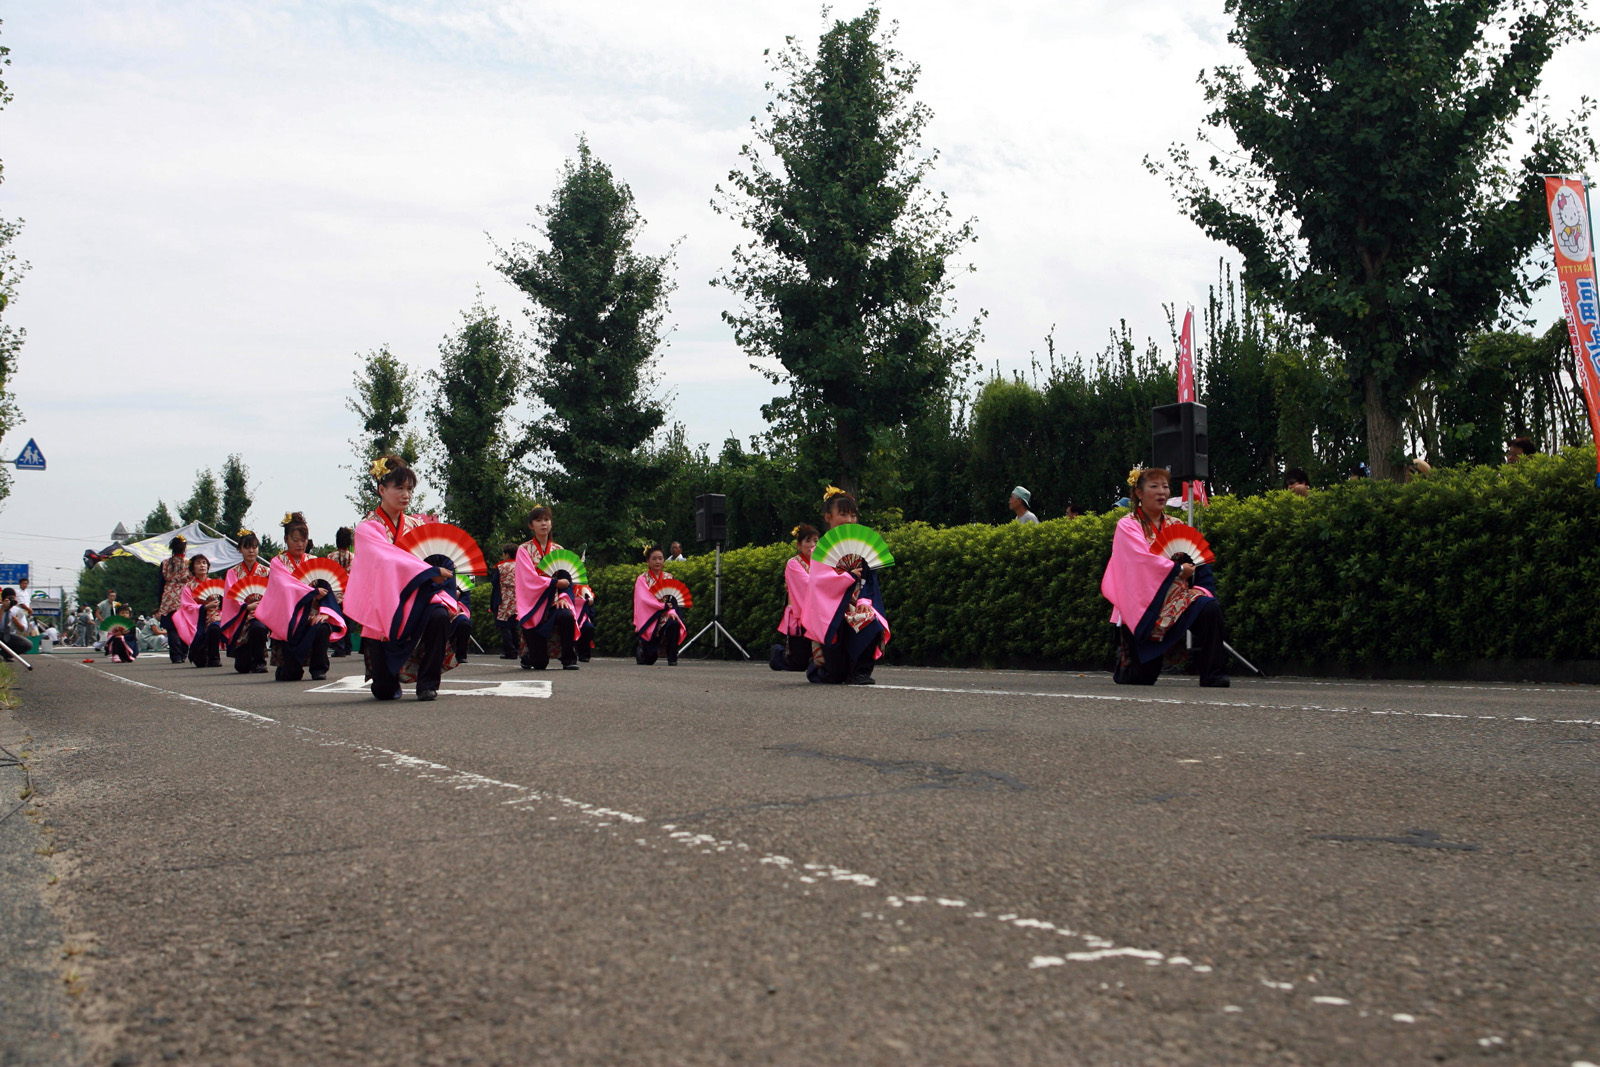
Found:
<box><xmin>1101</xmin><ymin>467</ymin><xmax>1229</xmax><ymax>688</ymax></box>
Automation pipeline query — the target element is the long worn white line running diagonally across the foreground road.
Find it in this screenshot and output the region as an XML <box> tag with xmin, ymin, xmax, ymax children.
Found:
<box><xmin>80</xmin><ymin>664</ymin><xmax>1400</xmax><ymax>1019</ymax></box>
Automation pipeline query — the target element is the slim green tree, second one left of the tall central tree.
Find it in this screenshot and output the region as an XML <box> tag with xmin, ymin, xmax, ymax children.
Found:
<box><xmin>427</xmin><ymin>294</ymin><xmax>525</xmax><ymax>555</ymax></box>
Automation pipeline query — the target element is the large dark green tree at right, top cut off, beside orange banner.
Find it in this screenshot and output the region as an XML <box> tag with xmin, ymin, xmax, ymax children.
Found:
<box><xmin>1147</xmin><ymin>0</ymin><xmax>1594</xmax><ymax>477</ymax></box>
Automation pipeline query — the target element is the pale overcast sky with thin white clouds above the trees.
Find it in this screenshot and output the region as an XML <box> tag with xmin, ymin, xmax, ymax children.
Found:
<box><xmin>0</xmin><ymin>0</ymin><xmax>1600</xmax><ymax>584</ymax></box>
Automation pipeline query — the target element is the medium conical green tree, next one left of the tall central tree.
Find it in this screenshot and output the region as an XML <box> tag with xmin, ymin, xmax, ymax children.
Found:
<box><xmin>496</xmin><ymin>138</ymin><xmax>672</xmax><ymax>560</ymax></box>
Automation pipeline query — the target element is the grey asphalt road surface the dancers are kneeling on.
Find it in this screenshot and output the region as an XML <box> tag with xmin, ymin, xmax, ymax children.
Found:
<box><xmin>0</xmin><ymin>656</ymin><xmax>1600</xmax><ymax>1067</ymax></box>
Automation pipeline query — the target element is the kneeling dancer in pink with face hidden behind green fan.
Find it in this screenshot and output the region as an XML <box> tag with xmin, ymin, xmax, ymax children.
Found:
<box><xmin>802</xmin><ymin>486</ymin><xmax>894</xmax><ymax>685</ymax></box>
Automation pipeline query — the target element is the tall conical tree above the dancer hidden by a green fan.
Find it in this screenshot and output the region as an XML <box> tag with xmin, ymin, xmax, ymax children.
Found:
<box><xmin>714</xmin><ymin>8</ymin><xmax>981</xmax><ymax>490</ymax></box>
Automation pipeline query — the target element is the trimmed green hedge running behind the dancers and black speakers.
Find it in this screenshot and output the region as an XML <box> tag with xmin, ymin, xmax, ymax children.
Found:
<box><xmin>563</xmin><ymin>448</ymin><xmax>1600</xmax><ymax>669</ymax></box>
